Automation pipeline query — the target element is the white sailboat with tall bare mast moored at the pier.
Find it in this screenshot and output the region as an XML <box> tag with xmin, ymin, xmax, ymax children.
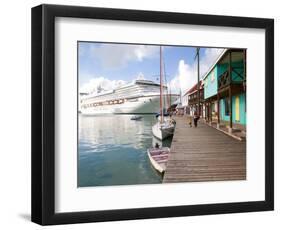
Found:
<box><xmin>152</xmin><ymin>46</ymin><xmax>175</xmax><ymax>140</ymax></box>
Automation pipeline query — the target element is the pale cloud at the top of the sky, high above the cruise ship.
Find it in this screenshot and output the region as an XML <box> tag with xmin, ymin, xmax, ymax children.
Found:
<box><xmin>91</xmin><ymin>44</ymin><xmax>159</xmax><ymax>68</ymax></box>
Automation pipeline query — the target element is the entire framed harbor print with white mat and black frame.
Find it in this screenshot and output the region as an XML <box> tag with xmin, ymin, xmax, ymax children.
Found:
<box><xmin>32</xmin><ymin>5</ymin><xmax>274</xmax><ymax>225</ymax></box>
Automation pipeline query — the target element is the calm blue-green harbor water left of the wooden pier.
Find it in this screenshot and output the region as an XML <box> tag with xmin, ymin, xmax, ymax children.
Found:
<box><xmin>78</xmin><ymin>114</ymin><xmax>171</xmax><ymax>187</ymax></box>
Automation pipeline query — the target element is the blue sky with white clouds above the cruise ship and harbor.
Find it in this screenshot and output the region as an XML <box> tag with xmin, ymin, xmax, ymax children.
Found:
<box><xmin>78</xmin><ymin>42</ymin><xmax>223</xmax><ymax>93</ymax></box>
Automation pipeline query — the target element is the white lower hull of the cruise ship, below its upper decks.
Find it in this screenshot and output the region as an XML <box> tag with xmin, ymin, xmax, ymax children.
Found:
<box><xmin>81</xmin><ymin>95</ymin><xmax>176</xmax><ymax>115</ymax></box>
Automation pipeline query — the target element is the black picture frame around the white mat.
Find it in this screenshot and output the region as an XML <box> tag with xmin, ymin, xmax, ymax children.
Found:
<box><xmin>31</xmin><ymin>5</ymin><xmax>274</xmax><ymax>225</ymax></box>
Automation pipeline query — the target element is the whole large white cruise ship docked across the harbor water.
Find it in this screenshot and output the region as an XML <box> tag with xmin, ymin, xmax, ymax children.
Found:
<box><xmin>79</xmin><ymin>80</ymin><xmax>179</xmax><ymax>114</ymax></box>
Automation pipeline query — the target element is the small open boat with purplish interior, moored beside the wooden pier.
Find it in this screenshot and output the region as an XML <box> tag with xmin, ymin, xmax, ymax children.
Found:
<box><xmin>147</xmin><ymin>147</ymin><xmax>170</xmax><ymax>173</ymax></box>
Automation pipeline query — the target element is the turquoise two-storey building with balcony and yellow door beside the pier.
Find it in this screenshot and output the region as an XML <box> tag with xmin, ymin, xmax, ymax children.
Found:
<box><xmin>203</xmin><ymin>49</ymin><xmax>246</xmax><ymax>131</ymax></box>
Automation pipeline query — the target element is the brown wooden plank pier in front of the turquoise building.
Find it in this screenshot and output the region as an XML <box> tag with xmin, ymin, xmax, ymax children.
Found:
<box><xmin>163</xmin><ymin>117</ymin><xmax>246</xmax><ymax>183</ymax></box>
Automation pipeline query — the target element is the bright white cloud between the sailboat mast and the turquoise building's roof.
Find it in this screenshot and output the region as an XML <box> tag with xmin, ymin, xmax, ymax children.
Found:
<box><xmin>169</xmin><ymin>48</ymin><xmax>223</xmax><ymax>94</ymax></box>
